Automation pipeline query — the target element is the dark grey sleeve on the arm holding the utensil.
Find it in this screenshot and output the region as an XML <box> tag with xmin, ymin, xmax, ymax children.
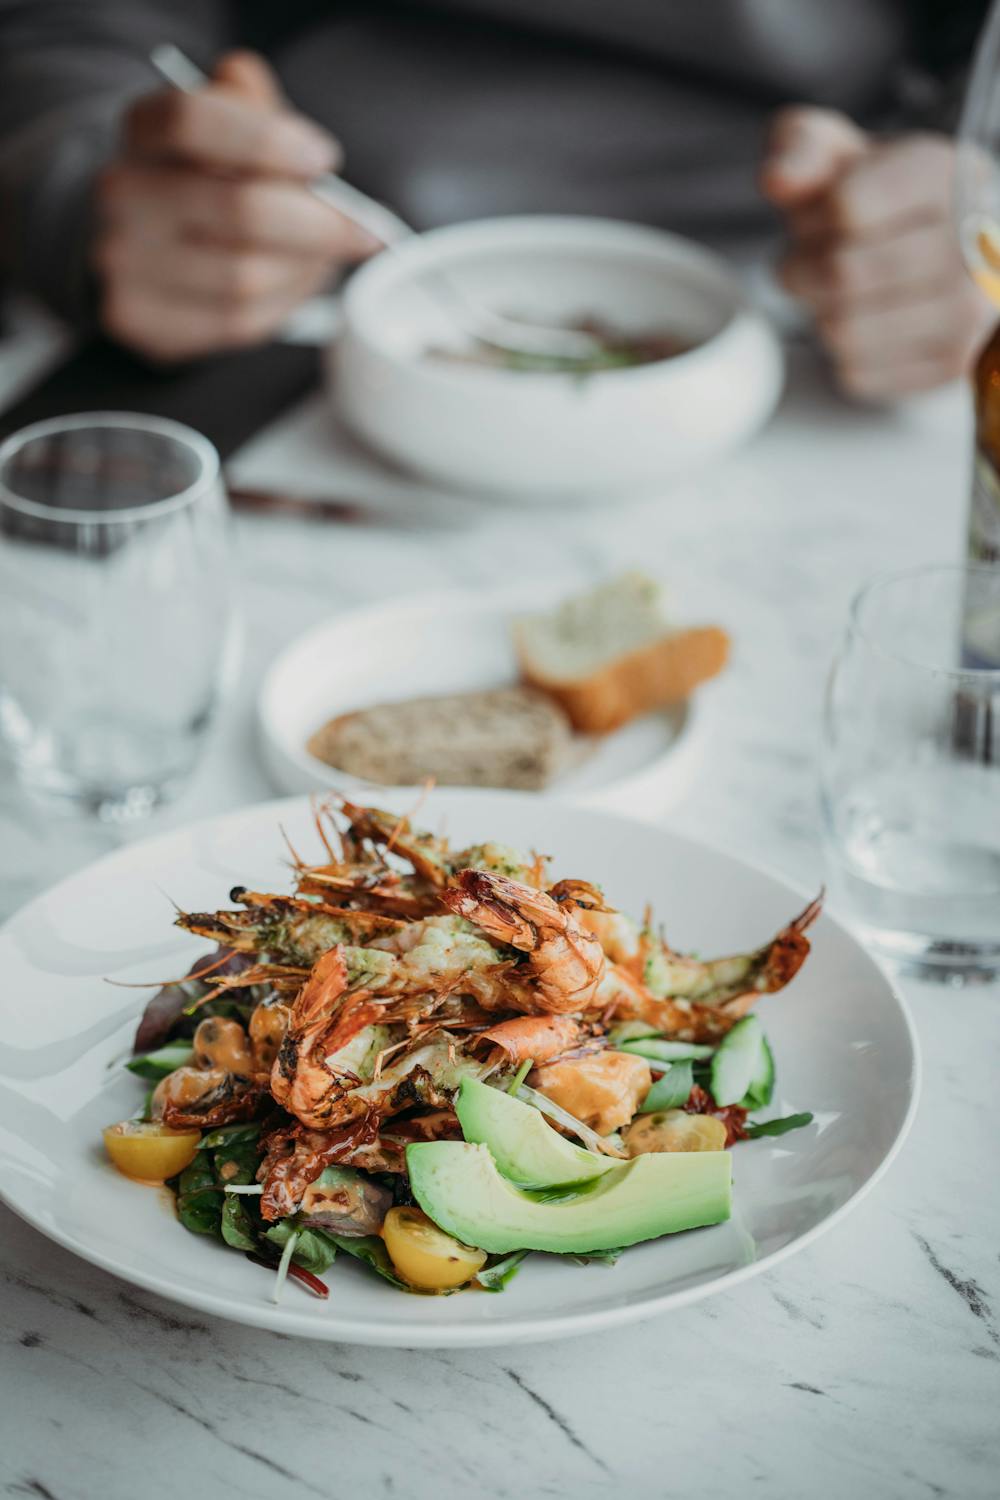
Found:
<box><xmin>0</xmin><ymin>0</ymin><xmax>229</xmax><ymax>324</ymax></box>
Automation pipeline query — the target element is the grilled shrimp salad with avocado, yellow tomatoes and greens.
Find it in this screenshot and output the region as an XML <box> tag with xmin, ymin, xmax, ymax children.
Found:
<box><xmin>103</xmin><ymin>801</ymin><xmax>820</xmax><ymax>1298</ymax></box>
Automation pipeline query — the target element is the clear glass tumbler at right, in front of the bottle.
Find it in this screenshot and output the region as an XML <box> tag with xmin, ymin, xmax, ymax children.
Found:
<box><xmin>822</xmin><ymin>567</ymin><xmax>1000</xmax><ymax>983</ymax></box>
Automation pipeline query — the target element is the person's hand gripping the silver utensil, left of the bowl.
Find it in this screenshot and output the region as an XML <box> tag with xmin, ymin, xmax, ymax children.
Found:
<box><xmin>91</xmin><ymin>53</ymin><xmax>378</xmax><ymax>360</ymax></box>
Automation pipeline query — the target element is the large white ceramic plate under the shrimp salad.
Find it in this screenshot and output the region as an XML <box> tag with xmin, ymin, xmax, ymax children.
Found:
<box><xmin>0</xmin><ymin>792</ymin><xmax>918</xmax><ymax>1347</ymax></box>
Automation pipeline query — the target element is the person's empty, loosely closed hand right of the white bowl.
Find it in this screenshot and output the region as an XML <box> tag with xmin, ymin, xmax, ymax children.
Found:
<box><xmin>760</xmin><ymin>108</ymin><xmax>997</xmax><ymax>401</ymax></box>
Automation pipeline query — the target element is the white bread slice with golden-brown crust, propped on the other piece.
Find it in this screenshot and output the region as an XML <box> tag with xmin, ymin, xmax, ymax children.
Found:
<box><xmin>514</xmin><ymin>573</ymin><xmax>729</xmax><ymax>734</ymax></box>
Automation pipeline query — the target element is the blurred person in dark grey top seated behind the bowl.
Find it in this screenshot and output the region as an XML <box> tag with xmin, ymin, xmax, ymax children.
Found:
<box><xmin>0</xmin><ymin>0</ymin><xmax>988</xmax><ymax>399</ymax></box>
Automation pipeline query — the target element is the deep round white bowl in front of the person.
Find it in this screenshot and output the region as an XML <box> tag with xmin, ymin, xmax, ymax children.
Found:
<box><xmin>331</xmin><ymin>218</ymin><xmax>783</xmax><ymax>500</ymax></box>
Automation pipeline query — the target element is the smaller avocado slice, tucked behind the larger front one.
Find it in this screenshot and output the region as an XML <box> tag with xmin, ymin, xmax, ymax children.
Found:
<box><xmin>454</xmin><ymin>1079</ymin><xmax>615</xmax><ymax>1188</ymax></box>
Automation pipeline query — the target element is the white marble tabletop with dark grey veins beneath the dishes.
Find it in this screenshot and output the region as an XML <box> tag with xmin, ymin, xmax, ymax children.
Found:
<box><xmin>0</xmin><ymin>331</ymin><xmax>1000</xmax><ymax>1500</ymax></box>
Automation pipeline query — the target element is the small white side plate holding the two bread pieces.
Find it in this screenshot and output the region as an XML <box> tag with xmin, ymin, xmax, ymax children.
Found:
<box><xmin>256</xmin><ymin>587</ymin><xmax>707</xmax><ymax>812</ymax></box>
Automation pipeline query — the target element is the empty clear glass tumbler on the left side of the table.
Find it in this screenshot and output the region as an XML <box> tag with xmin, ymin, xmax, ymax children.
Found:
<box><xmin>0</xmin><ymin>413</ymin><xmax>231</xmax><ymax>821</ymax></box>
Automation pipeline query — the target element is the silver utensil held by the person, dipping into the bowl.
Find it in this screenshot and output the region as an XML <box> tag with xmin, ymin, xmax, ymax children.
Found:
<box><xmin>150</xmin><ymin>42</ymin><xmax>603</xmax><ymax>363</ymax></box>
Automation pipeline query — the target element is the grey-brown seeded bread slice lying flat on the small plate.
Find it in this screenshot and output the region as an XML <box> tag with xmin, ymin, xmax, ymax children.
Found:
<box><xmin>306</xmin><ymin>687</ymin><xmax>573</xmax><ymax>791</ymax></box>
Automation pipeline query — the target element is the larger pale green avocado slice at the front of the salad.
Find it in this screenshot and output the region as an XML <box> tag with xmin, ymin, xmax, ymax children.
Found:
<box><xmin>406</xmin><ymin>1140</ymin><xmax>732</xmax><ymax>1256</ymax></box>
